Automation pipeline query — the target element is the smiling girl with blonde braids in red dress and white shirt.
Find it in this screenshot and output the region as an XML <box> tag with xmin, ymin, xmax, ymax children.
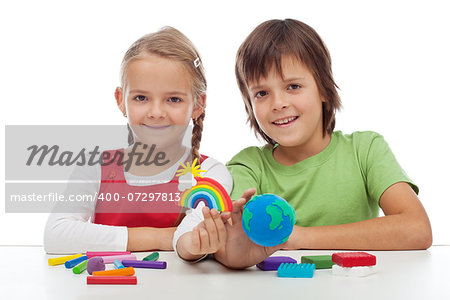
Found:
<box><xmin>44</xmin><ymin>27</ymin><xmax>232</xmax><ymax>253</ymax></box>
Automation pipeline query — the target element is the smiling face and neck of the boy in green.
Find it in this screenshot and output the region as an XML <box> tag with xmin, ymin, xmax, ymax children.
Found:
<box><xmin>249</xmin><ymin>56</ymin><xmax>328</xmax><ymax>164</ymax></box>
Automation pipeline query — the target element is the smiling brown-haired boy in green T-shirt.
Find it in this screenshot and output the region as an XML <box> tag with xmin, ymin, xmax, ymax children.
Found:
<box><xmin>175</xmin><ymin>19</ymin><xmax>432</xmax><ymax>268</ymax></box>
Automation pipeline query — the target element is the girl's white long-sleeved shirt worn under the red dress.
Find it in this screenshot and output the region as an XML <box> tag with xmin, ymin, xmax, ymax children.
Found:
<box><xmin>44</xmin><ymin>151</ymin><xmax>233</xmax><ymax>254</ymax></box>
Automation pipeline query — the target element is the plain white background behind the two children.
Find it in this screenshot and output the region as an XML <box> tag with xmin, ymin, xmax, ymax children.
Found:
<box><xmin>0</xmin><ymin>0</ymin><xmax>450</xmax><ymax>245</ymax></box>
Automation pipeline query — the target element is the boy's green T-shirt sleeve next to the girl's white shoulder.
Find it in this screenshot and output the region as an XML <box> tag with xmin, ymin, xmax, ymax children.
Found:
<box><xmin>227</xmin><ymin>147</ymin><xmax>262</xmax><ymax>200</ymax></box>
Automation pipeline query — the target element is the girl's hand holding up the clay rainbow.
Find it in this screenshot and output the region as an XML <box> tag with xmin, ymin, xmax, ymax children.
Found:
<box><xmin>177</xmin><ymin>207</ymin><xmax>230</xmax><ymax>260</ymax></box>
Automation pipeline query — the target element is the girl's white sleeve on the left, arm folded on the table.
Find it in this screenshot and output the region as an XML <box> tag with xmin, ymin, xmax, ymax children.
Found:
<box><xmin>44</xmin><ymin>166</ymin><xmax>128</xmax><ymax>254</ymax></box>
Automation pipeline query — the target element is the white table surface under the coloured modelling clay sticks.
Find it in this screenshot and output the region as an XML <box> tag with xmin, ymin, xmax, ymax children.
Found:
<box><xmin>0</xmin><ymin>246</ymin><xmax>450</xmax><ymax>300</ymax></box>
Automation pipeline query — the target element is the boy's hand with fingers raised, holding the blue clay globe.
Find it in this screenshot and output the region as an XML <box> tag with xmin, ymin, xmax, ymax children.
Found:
<box><xmin>214</xmin><ymin>188</ymin><xmax>285</xmax><ymax>269</ymax></box>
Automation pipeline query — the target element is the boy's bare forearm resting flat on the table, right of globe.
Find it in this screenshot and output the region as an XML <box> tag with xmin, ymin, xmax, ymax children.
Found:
<box><xmin>288</xmin><ymin>215</ymin><xmax>432</xmax><ymax>250</ymax></box>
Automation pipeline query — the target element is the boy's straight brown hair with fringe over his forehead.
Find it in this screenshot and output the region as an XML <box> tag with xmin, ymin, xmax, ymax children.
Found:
<box><xmin>235</xmin><ymin>19</ymin><xmax>341</xmax><ymax>145</ymax></box>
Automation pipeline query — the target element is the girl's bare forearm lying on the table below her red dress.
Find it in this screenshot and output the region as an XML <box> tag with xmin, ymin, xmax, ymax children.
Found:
<box><xmin>127</xmin><ymin>227</ymin><xmax>176</xmax><ymax>251</ymax></box>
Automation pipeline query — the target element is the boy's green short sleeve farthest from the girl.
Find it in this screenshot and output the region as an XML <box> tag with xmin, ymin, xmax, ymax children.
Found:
<box><xmin>363</xmin><ymin>133</ymin><xmax>419</xmax><ymax>204</ymax></box>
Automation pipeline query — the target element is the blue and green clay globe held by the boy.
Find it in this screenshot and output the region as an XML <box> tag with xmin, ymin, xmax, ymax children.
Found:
<box><xmin>242</xmin><ymin>194</ymin><xmax>296</xmax><ymax>247</ymax></box>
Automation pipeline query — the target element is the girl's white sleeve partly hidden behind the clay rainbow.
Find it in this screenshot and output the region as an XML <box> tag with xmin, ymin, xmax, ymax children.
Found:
<box><xmin>173</xmin><ymin>157</ymin><xmax>233</xmax><ymax>262</ymax></box>
